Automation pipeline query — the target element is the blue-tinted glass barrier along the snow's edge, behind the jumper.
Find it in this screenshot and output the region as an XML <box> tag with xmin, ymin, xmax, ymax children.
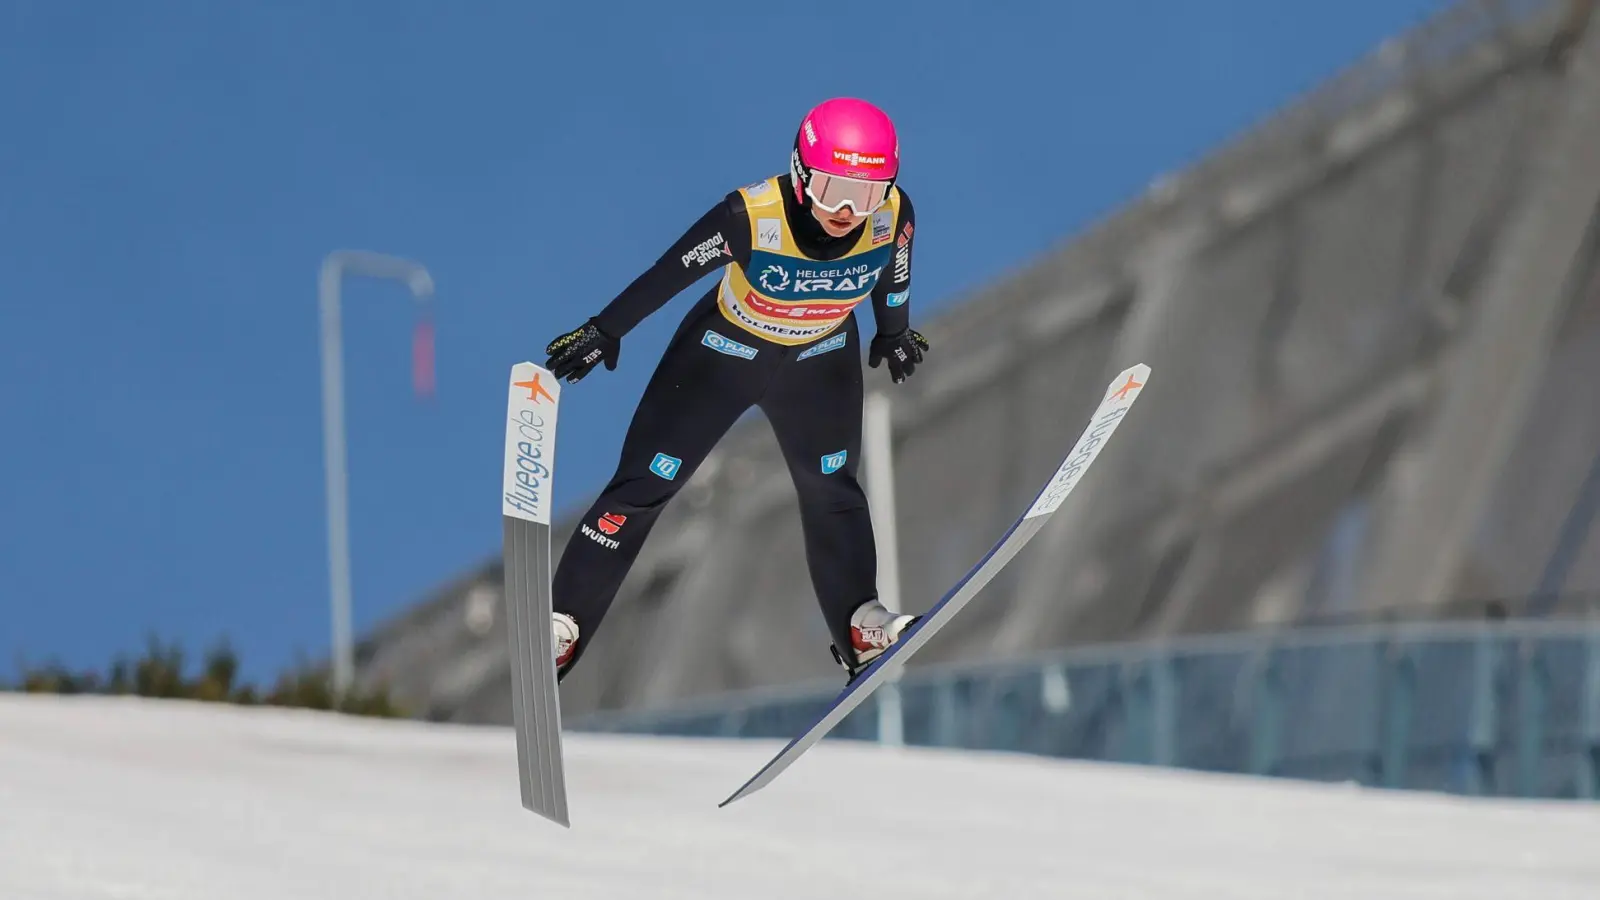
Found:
<box><xmin>570</xmin><ymin>621</ymin><xmax>1600</xmax><ymax>799</ymax></box>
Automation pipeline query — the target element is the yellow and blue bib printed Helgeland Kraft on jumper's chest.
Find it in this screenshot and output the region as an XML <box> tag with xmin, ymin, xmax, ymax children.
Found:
<box><xmin>717</xmin><ymin>176</ymin><xmax>899</xmax><ymax>346</ymax></box>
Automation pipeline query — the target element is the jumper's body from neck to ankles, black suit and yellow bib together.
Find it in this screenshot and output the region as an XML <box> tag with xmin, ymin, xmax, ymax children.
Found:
<box><xmin>552</xmin><ymin>175</ymin><xmax>915</xmax><ymax>665</ymax></box>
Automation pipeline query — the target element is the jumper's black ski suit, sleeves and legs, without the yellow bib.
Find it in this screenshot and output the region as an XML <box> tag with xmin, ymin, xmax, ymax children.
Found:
<box><xmin>552</xmin><ymin>175</ymin><xmax>925</xmax><ymax>676</ymax></box>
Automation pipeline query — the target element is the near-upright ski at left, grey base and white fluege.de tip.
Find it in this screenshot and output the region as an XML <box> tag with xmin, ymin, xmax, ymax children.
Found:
<box><xmin>501</xmin><ymin>362</ymin><xmax>571</xmax><ymax>828</ymax></box>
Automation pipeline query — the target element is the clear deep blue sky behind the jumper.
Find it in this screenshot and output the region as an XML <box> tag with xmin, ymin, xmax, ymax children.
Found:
<box><xmin>0</xmin><ymin>0</ymin><xmax>1443</xmax><ymax>679</ymax></box>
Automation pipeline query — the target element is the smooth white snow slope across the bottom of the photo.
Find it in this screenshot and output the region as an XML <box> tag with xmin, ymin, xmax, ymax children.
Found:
<box><xmin>0</xmin><ymin>695</ymin><xmax>1600</xmax><ymax>900</ymax></box>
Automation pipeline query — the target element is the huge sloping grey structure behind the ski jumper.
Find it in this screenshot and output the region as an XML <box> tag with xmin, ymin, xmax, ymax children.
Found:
<box><xmin>347</xmin><ymin>0</ymin><xmax>1600</xmax><ymax>722</ymax></box>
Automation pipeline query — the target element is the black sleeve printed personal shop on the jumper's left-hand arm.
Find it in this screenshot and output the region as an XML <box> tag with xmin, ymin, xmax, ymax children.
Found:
<box><xmin>594</xmin><ymin>191</ymin><xmax>750</xmax><ymax>340</ymax></box>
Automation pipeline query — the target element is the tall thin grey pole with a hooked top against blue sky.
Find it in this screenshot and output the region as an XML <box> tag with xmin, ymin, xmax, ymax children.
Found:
<box><xmin>317</xmin><ymin>250</ymin><xmax>434</xmax><ymax>697</ymax></box>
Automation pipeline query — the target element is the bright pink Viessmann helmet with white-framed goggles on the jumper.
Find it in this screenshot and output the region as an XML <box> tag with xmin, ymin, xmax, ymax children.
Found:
<box><xmin>789</xmin><ymin>98</ymin><xmax>899</xmax><ymax>215</ymax></box>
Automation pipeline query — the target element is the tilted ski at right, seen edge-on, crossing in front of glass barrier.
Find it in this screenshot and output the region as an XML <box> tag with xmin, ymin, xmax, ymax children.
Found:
<box><xmin>717</xmin><ymin>364</ymin><xmax>1150</xmax><ymax>807</ymax></box>
